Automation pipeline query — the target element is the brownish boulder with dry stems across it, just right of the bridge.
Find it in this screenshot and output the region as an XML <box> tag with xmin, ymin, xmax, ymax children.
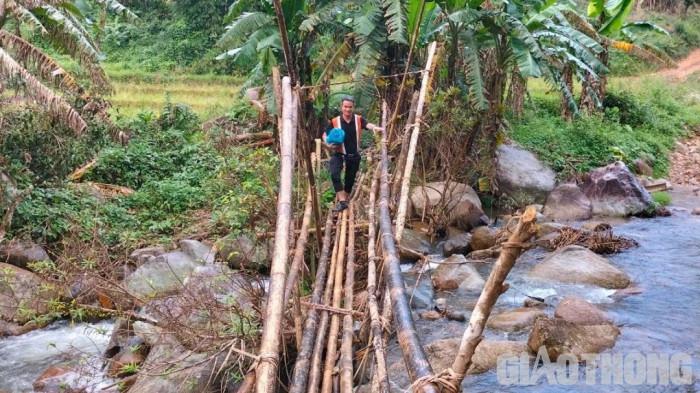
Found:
<box><xmin>410</xmin><ymin>182</ymin><xmax>488</xmax><ymax>231</ymax></box>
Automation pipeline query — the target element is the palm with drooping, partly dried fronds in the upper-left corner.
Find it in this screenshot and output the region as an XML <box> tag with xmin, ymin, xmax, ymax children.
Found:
<box><xmin>0</xmin><ymin>0</ymin><xmax>136</xmax><ymax>133</ymax></box>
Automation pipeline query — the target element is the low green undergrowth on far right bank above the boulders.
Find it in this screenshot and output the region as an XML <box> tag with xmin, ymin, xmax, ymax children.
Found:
<box><xmin>511</xmin><ymin>77</ymin><xmax>700</xmax><ymax>179</ymax></box>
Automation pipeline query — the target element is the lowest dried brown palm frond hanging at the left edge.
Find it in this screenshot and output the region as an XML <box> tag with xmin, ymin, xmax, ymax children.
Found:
<box><xmin>0</xmin><ymin>48</ymin><xmax>87</xmax><ymax>134</ymax></box>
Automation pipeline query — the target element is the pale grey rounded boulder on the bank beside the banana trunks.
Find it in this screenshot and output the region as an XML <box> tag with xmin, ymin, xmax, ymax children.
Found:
<box><xmin>496</xmin><ymin>144</ymin><xmax>556</xmax><ymax>206</ymax></box>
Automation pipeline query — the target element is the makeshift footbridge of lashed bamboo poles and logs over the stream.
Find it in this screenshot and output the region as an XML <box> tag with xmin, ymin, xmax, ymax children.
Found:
<box><xmin>249</xmin><ymin>66</ymin><xmax>536</xmax><ymax>393</ymax></box>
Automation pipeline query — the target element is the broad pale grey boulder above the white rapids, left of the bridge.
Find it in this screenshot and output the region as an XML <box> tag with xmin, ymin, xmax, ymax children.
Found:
<box><xmin>124</xmin><ymin>251</ymin><xmax>202</xmax><ymax>300</ymax></box>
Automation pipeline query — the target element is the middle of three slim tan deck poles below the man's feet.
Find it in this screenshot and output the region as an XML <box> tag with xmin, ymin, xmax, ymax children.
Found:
<box><xmin>321</xmin><ymin>210</ymin><xmax>348</xmax><ymax>393</ymax></box>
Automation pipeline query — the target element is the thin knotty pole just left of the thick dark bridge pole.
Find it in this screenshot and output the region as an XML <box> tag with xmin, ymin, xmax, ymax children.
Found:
<box><xmin>367</xmin><ymin>157</ymin><xmax>389</xmax><ymax>393</ymax></box>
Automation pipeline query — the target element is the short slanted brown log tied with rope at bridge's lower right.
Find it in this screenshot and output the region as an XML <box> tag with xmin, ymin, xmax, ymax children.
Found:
<box><xmin>442</xmin><ymin>207</ymin><xmax>537</xmax><ymax>391</ymax></box>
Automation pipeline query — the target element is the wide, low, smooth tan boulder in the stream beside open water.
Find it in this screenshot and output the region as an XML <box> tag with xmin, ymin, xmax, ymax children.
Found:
<box><xmin>529</xmin><ymin>245</ymin><xmax>630</xmax><ymax>289</ymax></box>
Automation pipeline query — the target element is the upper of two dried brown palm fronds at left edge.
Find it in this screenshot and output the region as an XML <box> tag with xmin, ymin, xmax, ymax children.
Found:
<box><xmin>0</xmin><ymin>30</ymin><xmax>82</xmax><ymax>94</ymax></box>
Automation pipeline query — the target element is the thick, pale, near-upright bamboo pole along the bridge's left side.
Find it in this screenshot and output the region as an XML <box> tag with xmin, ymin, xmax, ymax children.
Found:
<box><xmin>255</xmin><ymin>77</ymin><xmax>296</xmax><ymax>393</ymax></box>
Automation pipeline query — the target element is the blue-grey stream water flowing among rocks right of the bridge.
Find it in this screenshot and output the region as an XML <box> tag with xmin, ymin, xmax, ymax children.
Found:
<box><xmin>389</xmin><ymin>188</ymin><xmax>700</xmax><ymax>393</ymax></box>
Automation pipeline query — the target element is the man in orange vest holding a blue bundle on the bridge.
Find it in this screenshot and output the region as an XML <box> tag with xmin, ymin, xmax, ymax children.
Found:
<box><xmin>323</xmin><ymin>96</ymin><xmax>382</xmax><ymax>212</ymax></box>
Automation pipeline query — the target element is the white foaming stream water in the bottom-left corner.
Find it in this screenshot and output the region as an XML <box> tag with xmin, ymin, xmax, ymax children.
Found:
<box><xmin>0</xmin><ymin>321</ymin><xmax>113</xmax><ymax>393</ymax></box>
